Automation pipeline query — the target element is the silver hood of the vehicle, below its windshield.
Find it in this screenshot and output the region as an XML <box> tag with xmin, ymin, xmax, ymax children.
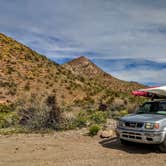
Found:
<box><xmin>120</xmin><ymin>114</ymin><xmax>166</xmax><ymax>122</ymax></box>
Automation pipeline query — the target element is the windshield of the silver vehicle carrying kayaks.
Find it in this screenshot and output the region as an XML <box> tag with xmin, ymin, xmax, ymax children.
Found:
<box><xmin>137</xmin><ymin>102</ymin><xmax>166</xmax><ymax>115</ymax></box>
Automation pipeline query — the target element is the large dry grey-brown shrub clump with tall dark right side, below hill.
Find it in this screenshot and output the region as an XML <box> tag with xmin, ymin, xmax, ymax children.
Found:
<box><xmin>19</xmin><ymin>96</ymin><xmax>61</xmax><ymax>130</ymax></box>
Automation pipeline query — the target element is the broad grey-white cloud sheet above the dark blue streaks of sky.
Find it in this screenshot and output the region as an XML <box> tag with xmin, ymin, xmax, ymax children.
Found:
<box><xmin>0</xmin><ymin>0</ymin><xmax>166</xmax><ymax>61</ymax></box>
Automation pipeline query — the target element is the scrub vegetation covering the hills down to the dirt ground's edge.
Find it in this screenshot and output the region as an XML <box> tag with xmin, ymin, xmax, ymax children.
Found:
<box><xmin>0</xmin><ymin>34</ymin><xmax>144</xmax><ymax>133</ymax></box>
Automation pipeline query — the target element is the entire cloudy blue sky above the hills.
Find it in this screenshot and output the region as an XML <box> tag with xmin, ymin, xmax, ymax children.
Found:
<box><xmin>0</xmin><ymin>0</ymin><xmax>166</xmax><ymax>85</ymax></box>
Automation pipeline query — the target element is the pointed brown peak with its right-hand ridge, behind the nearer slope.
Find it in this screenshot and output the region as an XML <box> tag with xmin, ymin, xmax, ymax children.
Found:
<box><xmin>63</xmin><ymin>56</ymin><xmax>144</xmax><ymax>93</ymax></box>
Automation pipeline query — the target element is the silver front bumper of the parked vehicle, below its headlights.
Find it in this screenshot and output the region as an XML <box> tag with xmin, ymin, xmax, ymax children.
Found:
<box><xmin>117</xmin><ymin>127</ymin><xmax>165</xmax><ymax>144</ymax></box>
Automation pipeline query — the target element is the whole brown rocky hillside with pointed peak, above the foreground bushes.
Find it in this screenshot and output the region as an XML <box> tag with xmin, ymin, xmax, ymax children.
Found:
<box><xmin>0</xmin><ymin>34</ymin><xmax>143</xmax><ymax>108</ymax></box>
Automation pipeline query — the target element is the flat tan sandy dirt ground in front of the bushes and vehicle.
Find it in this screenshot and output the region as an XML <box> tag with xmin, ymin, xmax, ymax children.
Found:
<box><xmin>0</xmin><ymin>131</ymin><xmax>166</xmax><ymax>166</ymax></box>
